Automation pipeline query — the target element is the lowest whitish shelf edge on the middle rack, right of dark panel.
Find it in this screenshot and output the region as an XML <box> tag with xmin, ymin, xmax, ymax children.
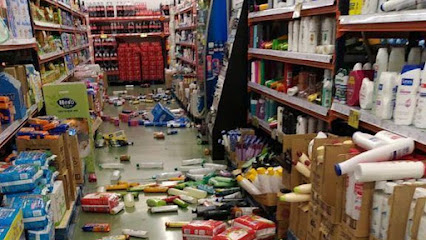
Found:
<box><xmin>248</xmin><ymin>82</ymin><xmax>328</xmax><ymax>117</ymax></box>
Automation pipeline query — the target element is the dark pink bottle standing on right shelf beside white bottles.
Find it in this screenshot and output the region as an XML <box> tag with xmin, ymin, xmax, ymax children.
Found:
<box><xmin>346</xmin><ymin>70</ymin><xmax>374</xmax><ymax>106</ymax></box>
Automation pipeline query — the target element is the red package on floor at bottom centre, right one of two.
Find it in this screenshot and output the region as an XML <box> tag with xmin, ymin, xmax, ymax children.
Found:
<box><xmin>233</xmin><ymin>215</ymin><xmax>276</xmax><ymax>240</ymax></box>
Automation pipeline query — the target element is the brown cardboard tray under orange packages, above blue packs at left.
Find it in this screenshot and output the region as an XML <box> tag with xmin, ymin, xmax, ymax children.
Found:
<box><xmin>16</xmin><ymin>136</ymin><xmax>67</xmax><ymax>172</ymax></box>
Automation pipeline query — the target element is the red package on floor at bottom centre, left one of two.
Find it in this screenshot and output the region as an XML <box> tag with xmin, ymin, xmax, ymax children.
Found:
<box><xmin>182</xmin><ymin>220</ymin><xmax>226</xmax><ymax>240</ymax></box>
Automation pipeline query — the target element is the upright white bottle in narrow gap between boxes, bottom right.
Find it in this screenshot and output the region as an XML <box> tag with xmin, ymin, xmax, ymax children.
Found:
<box><xmin>370</xmin><ymin>181</ymin><xmax>386</xmax><ymax>239</ymax></box>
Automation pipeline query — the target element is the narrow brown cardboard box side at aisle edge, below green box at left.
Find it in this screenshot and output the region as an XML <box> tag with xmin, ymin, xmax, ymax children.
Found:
<box><xmin>66</xmin><ymin>134</ymin><xmax>84</xmax><ymax>184</ymax></box>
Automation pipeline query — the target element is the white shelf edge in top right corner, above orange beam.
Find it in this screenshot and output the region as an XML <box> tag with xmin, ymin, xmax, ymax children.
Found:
<box><xmin>339</xmin><ymin>9</ymin><xmax>426</xmax><ymax>25</ymax></box>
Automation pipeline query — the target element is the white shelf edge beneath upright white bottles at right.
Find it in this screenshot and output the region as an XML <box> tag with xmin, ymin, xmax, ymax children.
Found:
<box><xmin>331</xmin><ymin>102</ymin><xmax>426</xmax><ymax>145</ymax></box>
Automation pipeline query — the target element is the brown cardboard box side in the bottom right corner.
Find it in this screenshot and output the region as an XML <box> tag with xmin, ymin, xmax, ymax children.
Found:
<box><xmin>387</xmin><ymin>184</ymin><xmax>426</xmax><ymax>240</ymax></box>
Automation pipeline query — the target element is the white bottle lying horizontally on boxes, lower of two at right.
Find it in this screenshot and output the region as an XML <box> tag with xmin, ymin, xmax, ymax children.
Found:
<box><xmin>354</xmin><ymin>161</ymin><xmax>425</xmax><ymax>182</ymax></box>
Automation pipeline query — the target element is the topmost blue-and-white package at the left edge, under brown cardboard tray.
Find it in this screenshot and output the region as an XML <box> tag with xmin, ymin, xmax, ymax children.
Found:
<box><xmin>0</xmin><ymin>165</ymin><xmax>43</xmax><ymax>193</ymax></box>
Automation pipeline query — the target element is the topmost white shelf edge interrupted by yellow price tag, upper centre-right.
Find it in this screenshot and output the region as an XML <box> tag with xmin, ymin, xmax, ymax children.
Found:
<box><xmin>248</xmin><ymin>0</ymin><xmax>334</xmax><ymax>19</ymax></box>
